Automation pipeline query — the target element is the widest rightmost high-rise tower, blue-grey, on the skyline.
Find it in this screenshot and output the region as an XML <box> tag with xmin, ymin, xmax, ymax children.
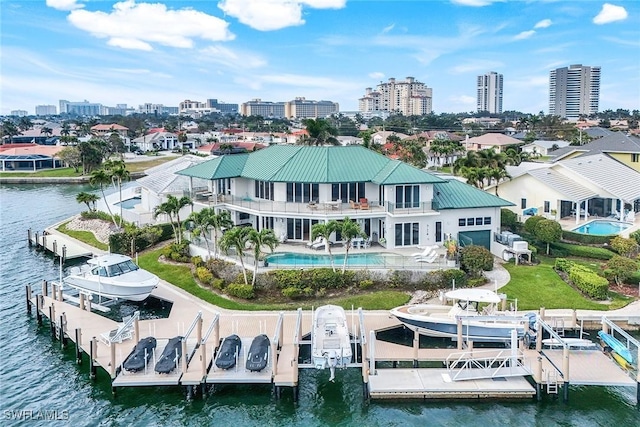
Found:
<box><xmin>549</xmin><ymin>64</ymin><xmax>600</xmax><ymax>119</ymax></box>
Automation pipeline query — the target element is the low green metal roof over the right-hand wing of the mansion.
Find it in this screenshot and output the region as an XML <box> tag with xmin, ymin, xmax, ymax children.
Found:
<box><xmin>433</xmin><ymin>179</ymin><xmax>515</xmax><ymax>210</ymax></box>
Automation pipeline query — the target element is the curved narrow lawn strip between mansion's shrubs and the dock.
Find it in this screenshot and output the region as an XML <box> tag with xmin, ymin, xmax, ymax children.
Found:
<box><xmin>138</xmin><ymin>249</ymin><xmax>409</xmax><ymax>311</ymax></box>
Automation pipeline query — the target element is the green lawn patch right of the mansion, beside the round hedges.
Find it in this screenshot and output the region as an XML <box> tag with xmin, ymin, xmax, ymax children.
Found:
<box><xmin>500</xmin><ymin>258</ymin><xmax>631</xmax><ymax>311</ymax></box>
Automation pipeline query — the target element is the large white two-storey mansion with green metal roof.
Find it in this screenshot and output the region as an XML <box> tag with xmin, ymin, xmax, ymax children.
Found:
<box><xmin>177</xmin><ymin>145</ymin><xmax>511</xmax><ymax>256</ymax></box>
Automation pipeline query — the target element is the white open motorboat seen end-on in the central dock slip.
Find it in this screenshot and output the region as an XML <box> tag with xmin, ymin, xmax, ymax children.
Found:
<box><xmin>311</xmin><ymin>305</ymin><xmax>352</xmax><ymax>381</ymax></box>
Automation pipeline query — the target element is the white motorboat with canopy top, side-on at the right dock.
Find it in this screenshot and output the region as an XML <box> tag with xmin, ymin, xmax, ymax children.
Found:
<box><xmin>391</xmin><ymin>289</ymin><xmax>529</xmax><ymax>342</ymax></box>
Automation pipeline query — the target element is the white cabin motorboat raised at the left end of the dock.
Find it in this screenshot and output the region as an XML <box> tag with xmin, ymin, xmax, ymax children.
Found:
<box><xmin>62</xmin><ymin>254</ymin><xmax>159</xmax><ymax>301</ymax></box>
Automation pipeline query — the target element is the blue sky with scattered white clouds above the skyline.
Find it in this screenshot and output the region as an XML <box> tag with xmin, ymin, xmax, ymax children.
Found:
<box><xmin>0</xmin><ymin>0</ymin><xmax>640</xmax><ymax>114</ymax></box>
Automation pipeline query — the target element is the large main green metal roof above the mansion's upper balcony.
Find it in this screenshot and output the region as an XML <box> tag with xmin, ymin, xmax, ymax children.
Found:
<box><xmin>180</xmin><ymin>145</ymin><xmax>444</xmax><ymax>185</ymax></box>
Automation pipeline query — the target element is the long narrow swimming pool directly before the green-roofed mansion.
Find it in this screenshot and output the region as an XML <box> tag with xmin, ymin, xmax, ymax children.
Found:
<box><xmin>266</xmin><ymin>252</ymin><xmax>407</xmax><ymax>268</ymax></box>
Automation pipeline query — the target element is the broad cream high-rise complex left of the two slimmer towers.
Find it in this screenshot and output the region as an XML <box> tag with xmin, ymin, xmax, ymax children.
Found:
<box><xmin>358</xmin><ymin>77</ymin><xmax>433</xmax><ymax>116</ymax></box>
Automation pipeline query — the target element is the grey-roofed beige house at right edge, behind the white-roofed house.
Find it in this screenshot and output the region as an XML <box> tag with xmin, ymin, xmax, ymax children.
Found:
<box><xmin>552</xmin><ymin>132</ymin><xmax>640</xmax><ymax>172</ymax></box>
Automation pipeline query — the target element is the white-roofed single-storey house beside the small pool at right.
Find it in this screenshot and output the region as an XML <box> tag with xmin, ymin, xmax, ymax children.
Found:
<box><xmin>487</xmin><ymin>153</ymin><xmax>640</xmax><ymax>223</ymax></box>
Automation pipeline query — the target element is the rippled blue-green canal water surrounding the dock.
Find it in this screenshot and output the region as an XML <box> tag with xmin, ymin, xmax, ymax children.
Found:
<box><xmin>0</xmin><ymin>185</ymin><xmax>640</xmax><ymax>426</ymax></box>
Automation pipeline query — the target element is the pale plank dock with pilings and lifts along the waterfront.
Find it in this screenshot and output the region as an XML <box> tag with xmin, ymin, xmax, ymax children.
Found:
<box><xmin>22</xmin><ymin>281</ymin><xmax>640</xmax><ymax>399</ymax></box>
